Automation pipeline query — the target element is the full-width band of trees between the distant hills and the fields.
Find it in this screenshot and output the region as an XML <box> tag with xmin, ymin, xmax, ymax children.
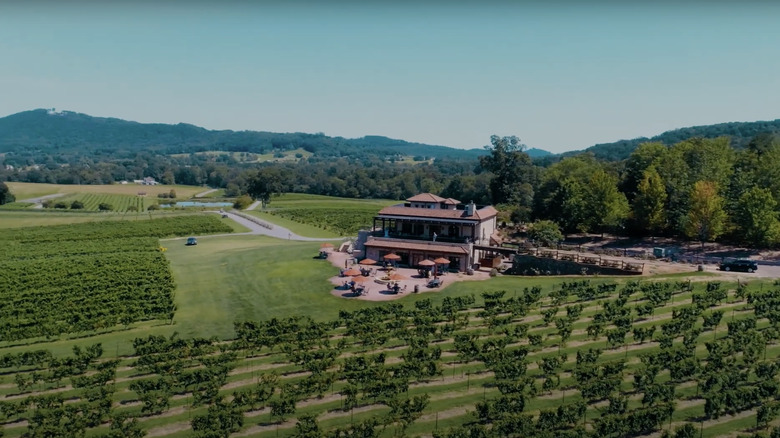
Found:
<box><xmin>0</xmin><ymin>134</ymin><xmax>780</xmax><ymax>247</ymax></box>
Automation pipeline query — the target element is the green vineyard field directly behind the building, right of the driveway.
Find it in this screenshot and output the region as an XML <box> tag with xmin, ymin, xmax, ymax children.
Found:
<box><xmin>250</xmin><ymin>193</ymin><xmax>401</xmax><ymax>237</ymax></box>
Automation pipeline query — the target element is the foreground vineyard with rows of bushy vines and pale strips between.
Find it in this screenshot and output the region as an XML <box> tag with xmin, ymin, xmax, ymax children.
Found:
<box><xmin>0</xmin><ymin>280</ymin><xmax>780</xmax><ymax>438</ymax></box>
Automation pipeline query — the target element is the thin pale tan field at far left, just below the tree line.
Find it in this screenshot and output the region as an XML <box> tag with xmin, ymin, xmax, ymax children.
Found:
<box><xmin>6</xmin><ymin>181</ymin><xmax>208</xmax><ymax>200</ymax></box>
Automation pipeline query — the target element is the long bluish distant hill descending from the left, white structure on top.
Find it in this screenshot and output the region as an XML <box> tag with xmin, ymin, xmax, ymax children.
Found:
<box><xmin>0</xmin><ymin>109</ymin><xmax>532</xmax><ymax>163</ymax></box>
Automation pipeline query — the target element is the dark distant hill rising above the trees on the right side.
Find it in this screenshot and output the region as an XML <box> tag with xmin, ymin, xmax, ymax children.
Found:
<box><xmin>561</xmin><ymin>119</ymin><xmax>780</xmax><ymax>161</ymax></box>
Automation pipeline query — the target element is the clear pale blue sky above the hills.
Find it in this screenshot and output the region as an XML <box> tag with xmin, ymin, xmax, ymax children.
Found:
<box><xmin>0</xmin><ymin>0</ymin><xmax>780</xmax><ymax>152</ymax></box>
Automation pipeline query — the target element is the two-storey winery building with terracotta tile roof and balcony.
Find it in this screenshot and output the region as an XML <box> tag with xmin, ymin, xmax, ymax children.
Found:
<box><xmin>363</xmin><ymin>193</ymin><xmax>498</xmax><ymax>271</ymax></box>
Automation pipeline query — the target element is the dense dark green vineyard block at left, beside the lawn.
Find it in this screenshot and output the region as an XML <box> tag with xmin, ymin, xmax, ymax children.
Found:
<box><xmin>0</xmin><ymin>216</ymin><xmax>231</xmax><ymax>343</ymax></box>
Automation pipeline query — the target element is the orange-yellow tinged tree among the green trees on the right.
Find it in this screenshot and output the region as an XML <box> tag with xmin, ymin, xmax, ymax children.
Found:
<box><xmin>685</xmin><ymin>181</ymin><xmax>727</xmax><ymax>247</ymax></box>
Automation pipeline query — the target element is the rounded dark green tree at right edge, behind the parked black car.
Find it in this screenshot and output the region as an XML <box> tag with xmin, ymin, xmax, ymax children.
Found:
<box><xmin>735</xmin><ymin>187</ymin><xmax>780</xmax><ymax>246</ymax></box>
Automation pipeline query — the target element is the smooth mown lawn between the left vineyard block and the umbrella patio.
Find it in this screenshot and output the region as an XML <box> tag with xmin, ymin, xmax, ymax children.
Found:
<box><xmin>165</xmin><ymin>236</ymin><xmax>381</xmax><ymax>339</ymax></box>
